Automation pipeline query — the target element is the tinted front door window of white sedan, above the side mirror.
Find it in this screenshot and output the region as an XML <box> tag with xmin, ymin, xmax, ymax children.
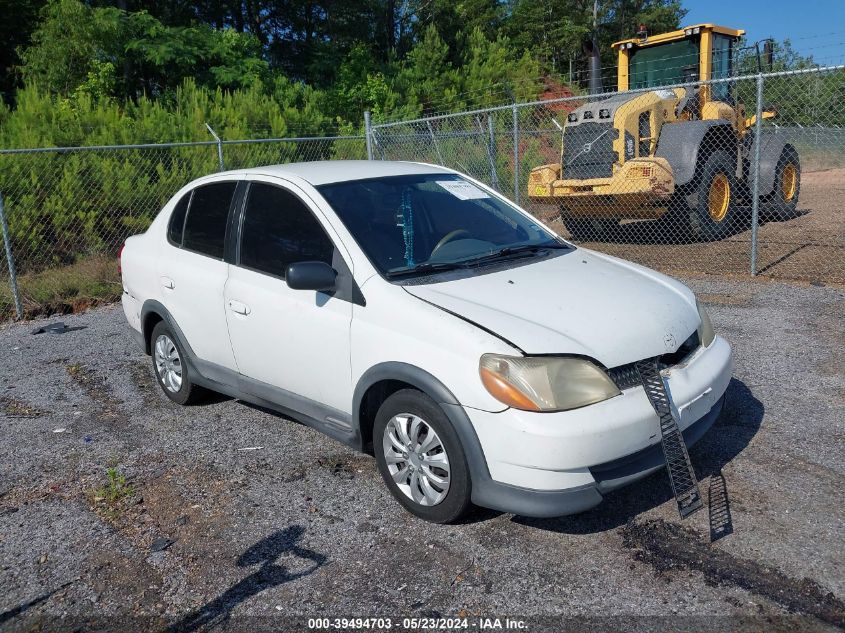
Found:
<box><xmin>241</xmin><ymin>183</ymin><xmax>334</xmax><ymax>277</ymax></box>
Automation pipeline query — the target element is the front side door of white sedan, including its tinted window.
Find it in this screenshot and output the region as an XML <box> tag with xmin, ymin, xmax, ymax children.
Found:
<box><xmin>224</xmin><ymin>181</ymin><xmax>352</xmax><ymax>430</ymax></box>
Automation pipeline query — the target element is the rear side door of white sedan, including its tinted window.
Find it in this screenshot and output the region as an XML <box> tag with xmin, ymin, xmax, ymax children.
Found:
<box><xmin>158</xmin><ymin>180</ymin><xmax>238</xmax><ymax>370</ymax></box>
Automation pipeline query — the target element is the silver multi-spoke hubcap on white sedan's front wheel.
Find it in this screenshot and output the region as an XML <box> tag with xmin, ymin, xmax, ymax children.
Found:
<box><xmin>382</xmin><ymin>413</ymin><xmax>451</xmax><ymax>506</ymax></box>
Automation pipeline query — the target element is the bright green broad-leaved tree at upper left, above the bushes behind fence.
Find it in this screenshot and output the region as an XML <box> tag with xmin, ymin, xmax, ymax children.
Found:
<box><xmin>22</xmin><ymin>0</ymin><xmax>268</xmax><ymax>98</ymax></box>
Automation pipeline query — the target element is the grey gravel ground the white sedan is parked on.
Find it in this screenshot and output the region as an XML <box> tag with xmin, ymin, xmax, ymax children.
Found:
<box><xmin>0</xmin><ymin>278</ymin><xmax>845</xmax><ymax>631</ymax></box>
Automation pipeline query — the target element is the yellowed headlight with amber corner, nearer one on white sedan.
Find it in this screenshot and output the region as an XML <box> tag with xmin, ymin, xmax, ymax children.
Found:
<box><xmin>478</xmin><ymin>354</ymin><xmax>621</xmax><ymax>411</ymax></box>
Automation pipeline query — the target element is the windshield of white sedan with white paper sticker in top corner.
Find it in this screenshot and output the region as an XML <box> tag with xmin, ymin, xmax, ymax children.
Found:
<box><xmin>318</xmin><ymin>174</ymin><xmax>570</xmax><ymax>277</ymax></box>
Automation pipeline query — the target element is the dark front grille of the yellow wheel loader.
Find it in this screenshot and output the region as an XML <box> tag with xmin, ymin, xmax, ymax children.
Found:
<box><xmin>562</xmin><ymin>122</ymin><xmax>619</xmax><ymax>180</ymax></box>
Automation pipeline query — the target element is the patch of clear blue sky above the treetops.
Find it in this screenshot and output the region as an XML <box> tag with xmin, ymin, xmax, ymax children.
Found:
<box><xmin>683</xmin><ymin>0</ymin><xmax>845</xmax><ymax>65</ymax></box>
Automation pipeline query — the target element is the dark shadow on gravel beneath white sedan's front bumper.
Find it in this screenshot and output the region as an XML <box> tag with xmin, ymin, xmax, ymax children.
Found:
<box><xmin>512</xmin><ymin>378</ymin><xmax>765</xmax><ymax>534</ymax></box>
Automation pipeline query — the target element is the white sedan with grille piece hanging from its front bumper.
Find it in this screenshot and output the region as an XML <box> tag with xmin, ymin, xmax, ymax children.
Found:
<box><xmin>121</xmin><ymin>161</ymin><xmax>732</xmax><ymax>522</ymax></box>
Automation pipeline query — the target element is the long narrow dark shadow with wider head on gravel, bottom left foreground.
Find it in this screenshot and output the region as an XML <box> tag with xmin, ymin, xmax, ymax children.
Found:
<box><xmin>168</xmin><ymin>525</ymin><xmax>328</xmax><ymax>632</ymax></box>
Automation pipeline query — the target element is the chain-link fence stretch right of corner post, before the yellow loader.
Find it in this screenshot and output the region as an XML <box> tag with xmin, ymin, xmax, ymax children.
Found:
<box><xmin>369</xmin><ymin>67</ymin><xmax>845</xmax><ymax>283</ymax></box>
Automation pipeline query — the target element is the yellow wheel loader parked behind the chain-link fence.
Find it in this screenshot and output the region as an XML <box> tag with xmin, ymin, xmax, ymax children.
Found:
<box><xmin>528</xmin><ymin>24</ymin><xmax>801</xmax><ymax>241</ymax></box>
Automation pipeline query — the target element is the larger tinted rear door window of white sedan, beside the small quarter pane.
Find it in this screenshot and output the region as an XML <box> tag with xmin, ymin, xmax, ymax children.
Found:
<box><xmin>182</xmin><ymin>182</ymin><xmax>237</xmax><ymax>259</ymax></box>
